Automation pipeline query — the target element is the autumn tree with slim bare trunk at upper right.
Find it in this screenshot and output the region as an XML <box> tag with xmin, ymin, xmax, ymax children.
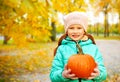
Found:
<box><xmin>91</xmin><ymin>0</ymin><xmax>120</xmax><ymax>37</ymax></box>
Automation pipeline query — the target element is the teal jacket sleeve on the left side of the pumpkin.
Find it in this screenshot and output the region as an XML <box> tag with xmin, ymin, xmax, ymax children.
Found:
<box><xmin>49</xmin><ymin>48</ymin><xmax>69</xmax><ymax>82</ymax></box>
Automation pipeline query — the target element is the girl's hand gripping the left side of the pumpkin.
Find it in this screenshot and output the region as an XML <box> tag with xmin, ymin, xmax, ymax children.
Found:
<box><xmin>62</xmin><ymin>65</ymin><xmax>78</xmax><ymax>79</ymax></box>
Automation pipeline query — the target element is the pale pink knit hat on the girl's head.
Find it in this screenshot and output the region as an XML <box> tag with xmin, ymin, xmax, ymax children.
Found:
<box><xmin>64</xmin><ymin>11</ymin><xmax>88</xmax><ymax>32</ymax></box>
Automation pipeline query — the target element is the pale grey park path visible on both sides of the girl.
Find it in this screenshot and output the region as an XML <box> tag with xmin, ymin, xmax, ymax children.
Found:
<box><xmin>14</xmin><ymin>40</ymin><xmax>120</xmax><ymax>82</ymax></box>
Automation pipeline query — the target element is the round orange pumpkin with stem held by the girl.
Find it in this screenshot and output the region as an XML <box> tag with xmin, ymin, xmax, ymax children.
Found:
<box><xmin>67</xmin><ymin>44</ymin><xmax>97</xmax><ymax>78</ymax></box>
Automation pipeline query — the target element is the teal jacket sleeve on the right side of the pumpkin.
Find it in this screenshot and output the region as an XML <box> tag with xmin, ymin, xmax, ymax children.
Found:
<box><xmin>94</xmin><ymin>48</ymin><xmax>107</xmax><ymax>82</ymax></box>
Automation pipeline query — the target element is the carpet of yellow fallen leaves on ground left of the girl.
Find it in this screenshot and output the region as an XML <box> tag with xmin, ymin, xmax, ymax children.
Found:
<box><xmin>0</xmin><ymin>43</ymin><xmax>54</xmax><ymax>77</ymax></box>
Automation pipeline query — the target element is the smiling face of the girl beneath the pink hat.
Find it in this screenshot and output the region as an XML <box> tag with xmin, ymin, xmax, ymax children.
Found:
<box><xmin>67</xmin><ymin>24</ymin><xmax>85</xmax><ymax>41</ymax></box>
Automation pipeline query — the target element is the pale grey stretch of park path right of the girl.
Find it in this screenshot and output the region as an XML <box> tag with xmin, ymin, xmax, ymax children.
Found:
<box><xmin>96</xmin><ymin>40</ymin><xmax>120</xmax><ymax>75</ymax></box>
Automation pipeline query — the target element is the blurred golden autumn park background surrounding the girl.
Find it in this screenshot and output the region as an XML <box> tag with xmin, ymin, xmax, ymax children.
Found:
<box><xmin>0</xmin><ymin>0</ymin><xmax>120</xmax><ymax>82</ymax></box>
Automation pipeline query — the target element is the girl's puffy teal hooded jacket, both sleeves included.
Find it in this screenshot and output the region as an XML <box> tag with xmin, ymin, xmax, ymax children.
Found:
<box><xmin>49</xmin><ymin>37</ymin><xmax>107</xmax><ymax>82</ymax></box>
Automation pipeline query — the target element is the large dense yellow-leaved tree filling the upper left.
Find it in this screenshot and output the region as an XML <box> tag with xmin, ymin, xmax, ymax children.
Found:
<box><xmin>0</xmin><ymin>0</ymin><xmax>51</xmax><ymax>44</ymax></box>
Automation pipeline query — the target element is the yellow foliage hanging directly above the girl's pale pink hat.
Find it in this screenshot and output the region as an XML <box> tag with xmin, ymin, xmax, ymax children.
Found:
<box><xmin>52</xmin><ymin>0</ymin><xmax>87</xmax><ymax>13</ymax></box>
